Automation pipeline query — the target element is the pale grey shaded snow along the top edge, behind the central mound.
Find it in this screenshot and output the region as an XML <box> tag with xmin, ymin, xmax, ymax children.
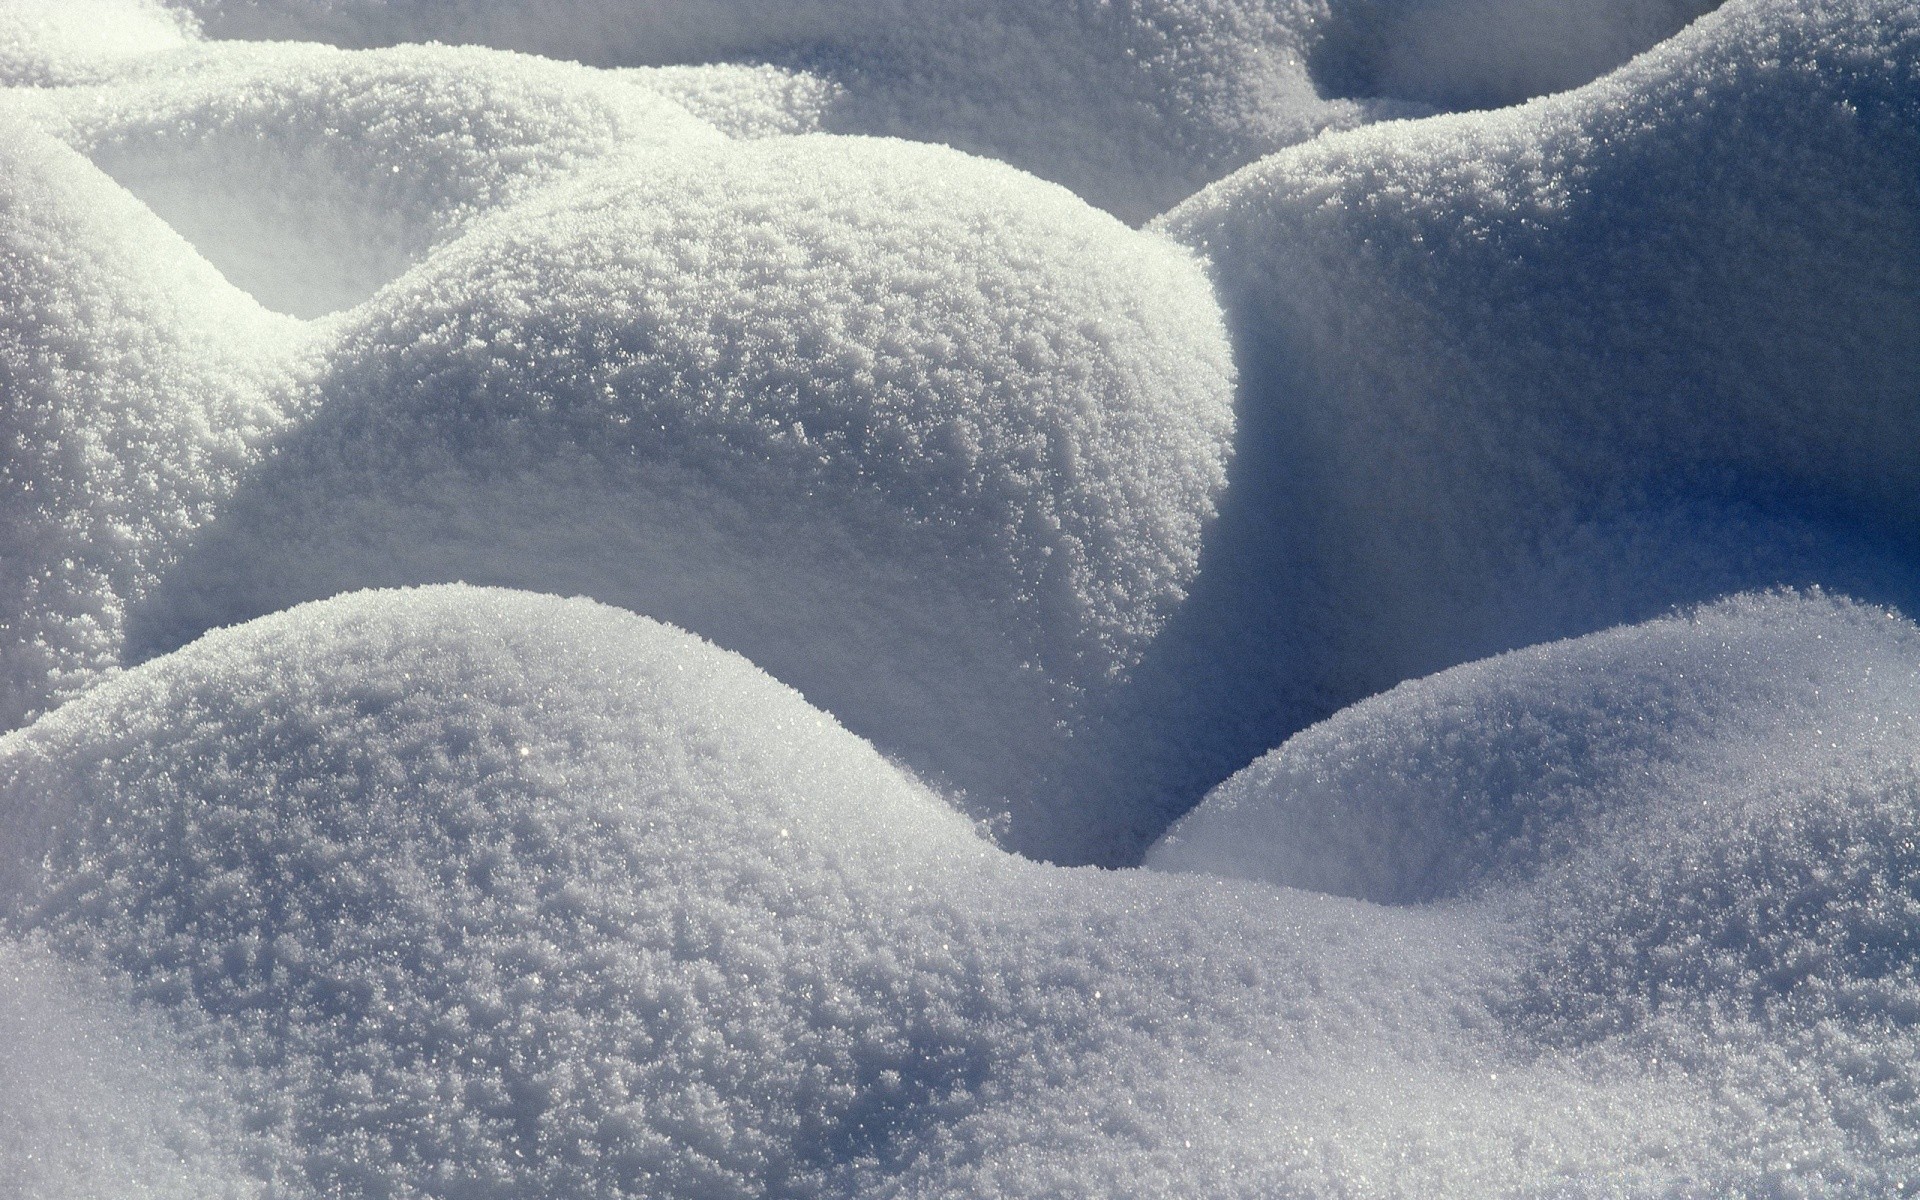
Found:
<box><xmin>165</xmin><ymin>0</ymin><xmax>1404</xmax><ymax>221</ymax></box>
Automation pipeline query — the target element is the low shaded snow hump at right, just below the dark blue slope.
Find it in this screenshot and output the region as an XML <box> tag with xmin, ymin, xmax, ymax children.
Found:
<box><xmin>1146</xmin><ymin>595</ymin><xmax>1920</xmax><ymax>904</ymax></box>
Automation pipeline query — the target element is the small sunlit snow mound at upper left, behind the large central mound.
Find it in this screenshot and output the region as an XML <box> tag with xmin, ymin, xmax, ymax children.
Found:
<box><xmin>28</xmin><ymin>44</ymin><xmax>720</xmax><ymax>317</ymax></box>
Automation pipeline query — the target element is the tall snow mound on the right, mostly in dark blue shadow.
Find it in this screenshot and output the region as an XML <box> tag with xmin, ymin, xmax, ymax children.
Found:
<box><xmin>1156</xmin><ymin>0</ymin><xmax>1920</xmax><ymax>747</ymax></box>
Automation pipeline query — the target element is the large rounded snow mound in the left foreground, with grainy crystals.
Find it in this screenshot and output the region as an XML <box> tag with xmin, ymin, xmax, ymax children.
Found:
<box><xmin>0</xmin><ymin>588</ymin><xmax>987</xmax><ymax>1196</ymax></box>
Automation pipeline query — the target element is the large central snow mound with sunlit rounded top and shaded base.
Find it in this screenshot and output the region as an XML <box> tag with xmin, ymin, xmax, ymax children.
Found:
<box><xmin>138</xmin><ymin>136</ymin><xmax>1233</xmax><ymax>858</ymax></box>
